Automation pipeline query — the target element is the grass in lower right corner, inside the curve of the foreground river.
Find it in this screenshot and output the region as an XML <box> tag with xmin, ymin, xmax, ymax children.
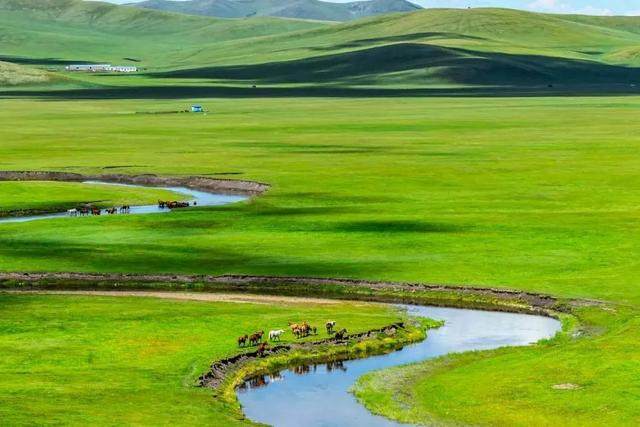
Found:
<box><xmin>354</xmin><ymin>308</ymin><xmax>640</xmax><ymax>426</ymax></box>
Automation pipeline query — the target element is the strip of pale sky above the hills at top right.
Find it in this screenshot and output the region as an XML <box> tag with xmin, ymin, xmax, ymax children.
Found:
<box><xmin>102</xmin><ymin>0</ymin><xmax>640</xmax><ymax>15</ymax></box>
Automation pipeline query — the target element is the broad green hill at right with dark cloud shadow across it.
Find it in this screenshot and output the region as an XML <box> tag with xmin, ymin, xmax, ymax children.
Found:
<box><xmin>152</xmin><ymin>9</ymin><xmax>640</xmax><ymax>86</ymax></box>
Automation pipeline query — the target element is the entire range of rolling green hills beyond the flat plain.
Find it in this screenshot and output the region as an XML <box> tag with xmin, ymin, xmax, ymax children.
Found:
<box><xmin>0</xmin><ymin>0</ymin><xmax>640</xmax><ymax>88</ymax></box>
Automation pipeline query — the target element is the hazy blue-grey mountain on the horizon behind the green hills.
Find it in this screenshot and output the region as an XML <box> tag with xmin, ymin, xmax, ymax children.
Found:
<box><xmin>131</xmin><ymin>0</ymin><xmax>422</xmax><ymax>21</ymax></box>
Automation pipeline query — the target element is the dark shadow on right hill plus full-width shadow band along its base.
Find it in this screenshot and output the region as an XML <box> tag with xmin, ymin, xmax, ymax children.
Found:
<box><xmin>0</xmin><ymin>44</ymin><xmax>640</xmax><ymax>100</ymax></box>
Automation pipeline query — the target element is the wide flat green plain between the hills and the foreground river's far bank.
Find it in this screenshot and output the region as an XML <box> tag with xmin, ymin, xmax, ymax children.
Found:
<box><xmin>0</xmin><ymin>93</ymin><xmax>640</xmax><ymax>423</ymax></box>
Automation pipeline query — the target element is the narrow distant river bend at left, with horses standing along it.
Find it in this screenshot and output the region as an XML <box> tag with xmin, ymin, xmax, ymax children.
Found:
<box><xmin>0</xmin><ymin>181</ymin><xmax>248</xmax><ymax>224</ymax></box>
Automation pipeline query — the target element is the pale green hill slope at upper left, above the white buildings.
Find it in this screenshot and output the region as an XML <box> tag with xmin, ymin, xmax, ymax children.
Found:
<box><xmin>0</xmin><ymin>0</ymin><xmax>324</xmax><ymax>68</ymax></box>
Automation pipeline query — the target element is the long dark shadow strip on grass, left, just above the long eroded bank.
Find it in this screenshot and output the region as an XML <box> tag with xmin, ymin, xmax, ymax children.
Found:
<box><xmin>0</xmin><ymin>233</ymin><xmax>381</xmax><ymax>277</ymax></box>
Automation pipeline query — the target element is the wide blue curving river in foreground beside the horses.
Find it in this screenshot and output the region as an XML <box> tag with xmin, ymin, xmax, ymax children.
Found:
<box><xmin>238</xmin><ymin>306</ymin><xmax>561</xmax><ymax>427</ymax></box>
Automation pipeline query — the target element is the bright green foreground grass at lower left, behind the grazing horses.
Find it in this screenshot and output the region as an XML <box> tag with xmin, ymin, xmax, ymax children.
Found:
<box><xmin>0</xmin><ymin>294</ymin><xmax>402</xmax><ymax>426</ymax></box>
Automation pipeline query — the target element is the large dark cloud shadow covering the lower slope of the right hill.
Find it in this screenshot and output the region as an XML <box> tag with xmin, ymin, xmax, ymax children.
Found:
<box><xmin>152</xmin><ymin>43</ymin><xmax>640</xmax><ymax>86</ymax></box>
